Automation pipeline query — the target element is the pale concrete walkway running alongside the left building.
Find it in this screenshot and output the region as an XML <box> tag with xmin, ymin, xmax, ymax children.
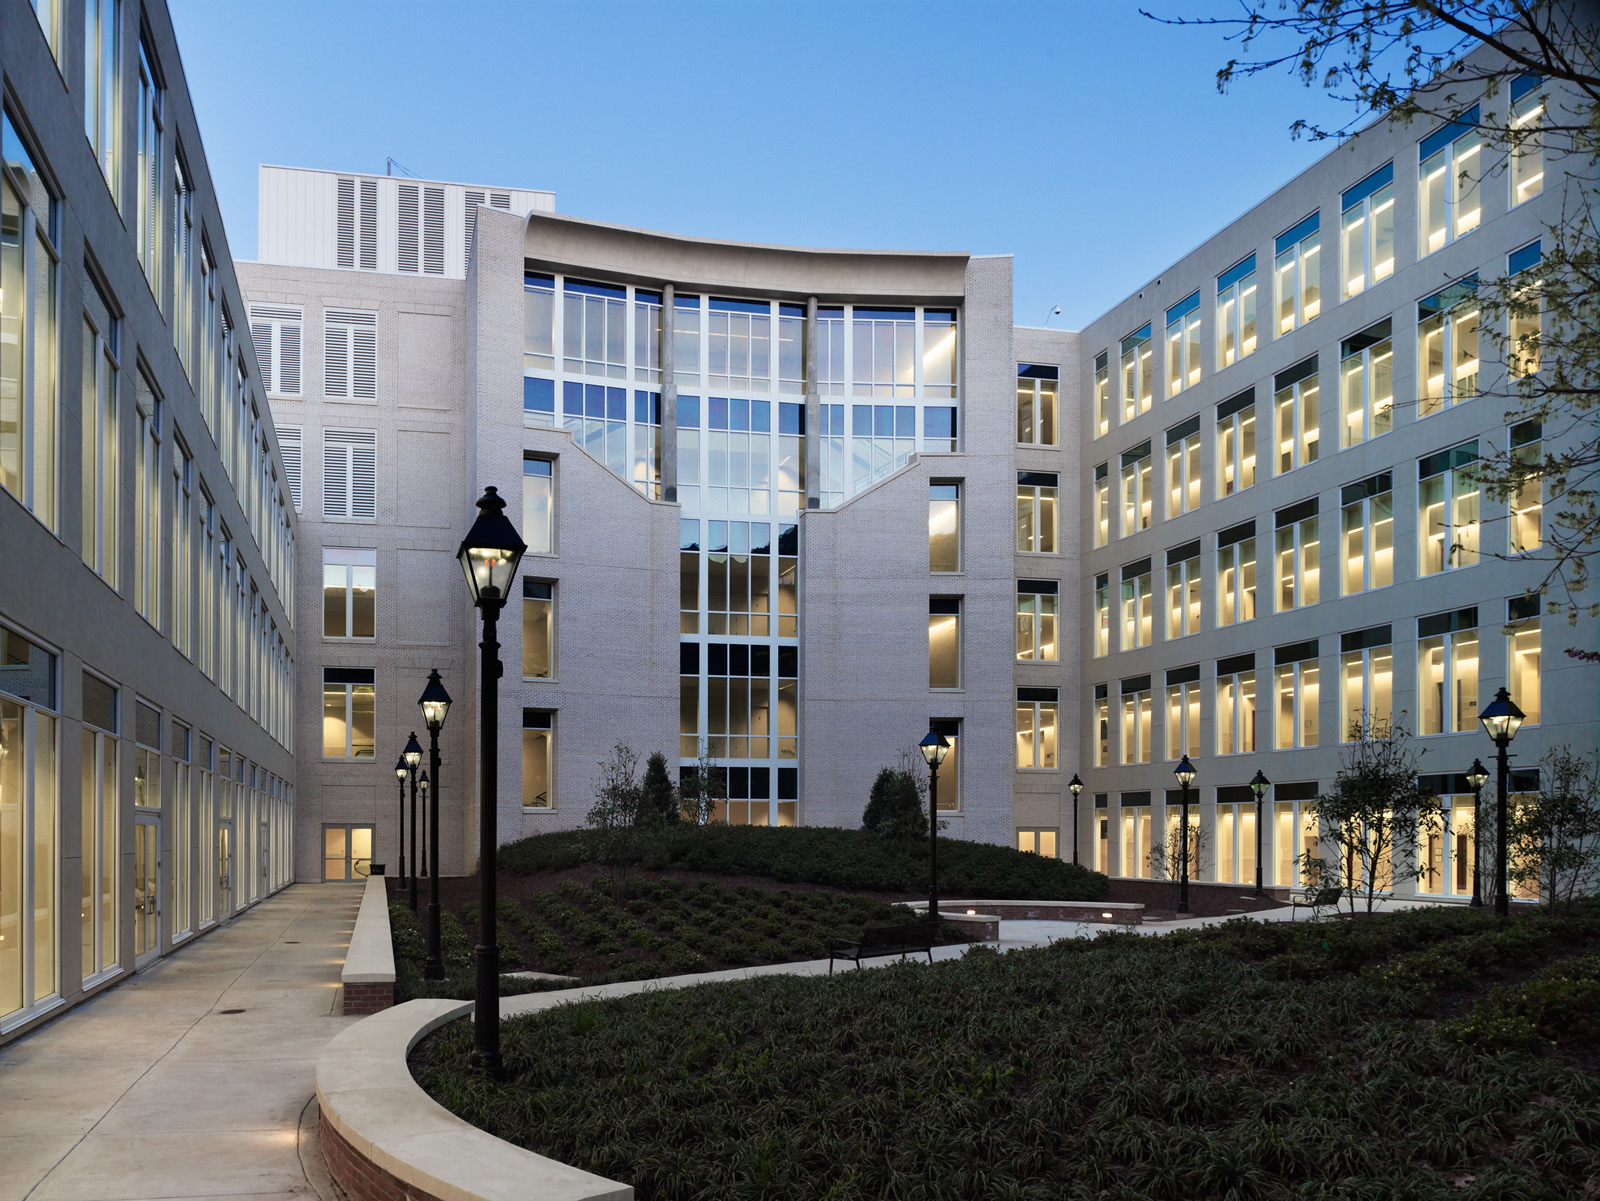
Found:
<box><xmin>0</xmin><ymin>884</ymin><xmax>362</xmax><ymax>1201</ymax></box>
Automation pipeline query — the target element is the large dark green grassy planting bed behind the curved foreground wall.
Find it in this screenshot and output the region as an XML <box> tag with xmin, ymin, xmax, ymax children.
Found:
<box><xmin>413</xmin><ymin>905</ymin><xmax>1600</xmax><ymax>1201</ymax></box>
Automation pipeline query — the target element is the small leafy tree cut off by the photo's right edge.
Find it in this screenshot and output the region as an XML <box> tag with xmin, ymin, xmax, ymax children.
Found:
<box><xmin>1507</xmin><ymin>747</ymin><xmax>1600</xmax><ymax>908</ymax></box>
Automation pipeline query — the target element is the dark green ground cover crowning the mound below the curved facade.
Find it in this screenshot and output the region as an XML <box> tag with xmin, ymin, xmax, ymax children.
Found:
<box><xmin>499</xmin><ymin>822</ymin><xmax>1109</xmax><ymax>900</ymax></box>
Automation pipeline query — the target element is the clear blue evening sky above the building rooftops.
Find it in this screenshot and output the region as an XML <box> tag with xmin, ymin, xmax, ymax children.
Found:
<box><xmin>170</xmin><ymin>0</ymin><xmax>1349</xmax><ymax>328</ymax></box>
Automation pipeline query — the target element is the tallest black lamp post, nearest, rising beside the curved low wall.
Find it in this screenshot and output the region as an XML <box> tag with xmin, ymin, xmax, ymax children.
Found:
<box><xmin>456</xmin><ymin>488</ymin><xmax>528</xmax><ymax>1076</ymax></box>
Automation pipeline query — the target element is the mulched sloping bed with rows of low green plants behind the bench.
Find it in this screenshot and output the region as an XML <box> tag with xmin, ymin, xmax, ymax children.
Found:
<box><xmin>389</xmin><ymin>876</ymin><xmax>965</xmax><ymax>1001</ymax></box>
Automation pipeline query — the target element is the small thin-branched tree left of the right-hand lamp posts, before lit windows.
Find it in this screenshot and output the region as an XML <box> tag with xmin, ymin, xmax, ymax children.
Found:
<box><xmin>1301</xmin><ymin>710</ymin><xmax>1443</xmax><ymax>913</ymax></box>
